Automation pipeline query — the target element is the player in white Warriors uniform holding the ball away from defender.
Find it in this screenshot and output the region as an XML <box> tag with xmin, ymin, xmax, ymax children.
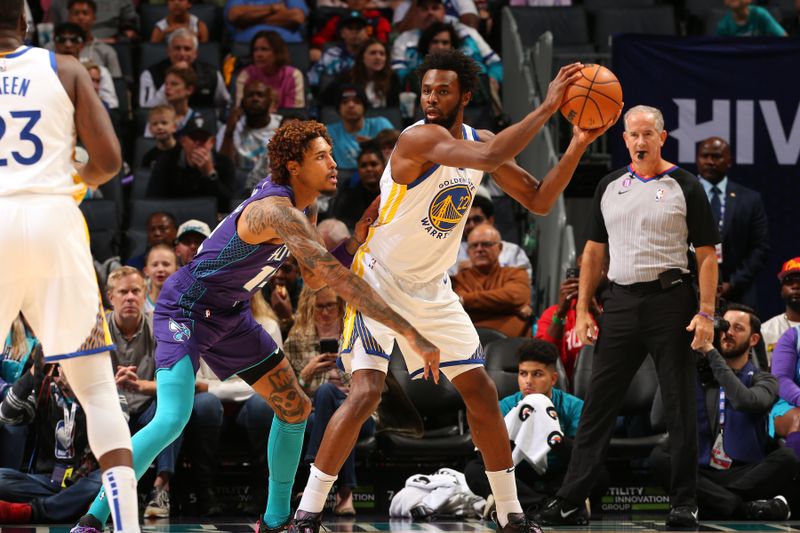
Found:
<box><xmin>289</xmin><ymin>50</ymin><xmax>620</xmax><ymax>533</ymax></box>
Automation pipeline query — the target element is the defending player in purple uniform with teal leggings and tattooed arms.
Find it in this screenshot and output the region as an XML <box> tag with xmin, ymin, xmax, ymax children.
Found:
<box><xmin>72</xmin><ymin>120</ymin><xmax>439</xmax><ymax>533</ymax></box>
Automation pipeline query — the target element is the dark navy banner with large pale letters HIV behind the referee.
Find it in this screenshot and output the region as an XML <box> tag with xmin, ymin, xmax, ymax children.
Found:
<box><xmin>609</xmin><ymin>35</ymin><xmax>800</xmax><ymax>318</ymax></box>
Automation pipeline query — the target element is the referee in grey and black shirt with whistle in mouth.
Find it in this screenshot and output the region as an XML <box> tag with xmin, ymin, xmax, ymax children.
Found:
<box><xmin>537</xmin><ymin>106</ymin><xmax>720</xmax><ymax>528</ymax></box>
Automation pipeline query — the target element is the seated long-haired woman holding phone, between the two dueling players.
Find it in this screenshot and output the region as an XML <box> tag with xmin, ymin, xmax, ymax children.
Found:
<box><xmin>284</xmin><ymin>287</ymin><xmax>375</xmax><ymax>515</ymax></box>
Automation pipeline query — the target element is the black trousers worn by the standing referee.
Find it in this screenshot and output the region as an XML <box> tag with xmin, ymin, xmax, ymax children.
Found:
<box><xmin>558</xmin><ymin>280</ymin><xmax>697</xmax><ymax>506</ymax></box>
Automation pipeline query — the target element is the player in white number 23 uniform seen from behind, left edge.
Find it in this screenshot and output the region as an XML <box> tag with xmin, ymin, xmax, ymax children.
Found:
<box><xmin>0</xmin><ymin>0</ymin><xmax>139</xmax><ymax>533</ymax></box>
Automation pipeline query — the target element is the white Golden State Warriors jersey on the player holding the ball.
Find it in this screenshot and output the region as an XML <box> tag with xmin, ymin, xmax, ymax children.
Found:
<box><xmin>362</xmin><ymin>121</ymin><xmax>483</xmax><ymax>283</ymax></box>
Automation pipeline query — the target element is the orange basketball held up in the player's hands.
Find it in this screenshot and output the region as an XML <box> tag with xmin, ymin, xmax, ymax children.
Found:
<box><xmin>561</xmin><ymin>65</ymin><xmax>622</xmax><ymax>130</ymax></box>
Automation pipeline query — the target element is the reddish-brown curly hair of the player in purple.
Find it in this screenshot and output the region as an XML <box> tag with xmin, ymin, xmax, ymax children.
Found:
<box><xmin>267</xmin><ymin>119</ymin><xmax>333</xmax><ymax>185</ymax></box>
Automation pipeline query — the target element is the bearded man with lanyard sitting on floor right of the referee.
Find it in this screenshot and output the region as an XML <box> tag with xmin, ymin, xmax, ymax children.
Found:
<box><xmin>650</xmin><ymin>304</ymin><xmax>800</xmax><ymax>520</ymax></box>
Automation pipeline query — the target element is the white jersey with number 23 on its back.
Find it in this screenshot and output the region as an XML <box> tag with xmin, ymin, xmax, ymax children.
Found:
<box><xmin>0</xmin><ymin>46</ymin><xmax>83</xmax><ymax>196</ymax></box>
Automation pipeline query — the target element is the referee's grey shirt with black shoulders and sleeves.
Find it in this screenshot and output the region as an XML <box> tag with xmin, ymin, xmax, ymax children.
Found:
<box><xmin>588</xmin><ymin>166</ymin><xmax>720</xmax><ymax>285</ymax></box>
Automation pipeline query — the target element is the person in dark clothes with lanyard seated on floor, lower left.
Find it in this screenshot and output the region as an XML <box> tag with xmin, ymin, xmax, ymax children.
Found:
<box><xmin>0</xmin><ymin>356</ymin><xmax>125</xmax><ymax>524</ymax></box>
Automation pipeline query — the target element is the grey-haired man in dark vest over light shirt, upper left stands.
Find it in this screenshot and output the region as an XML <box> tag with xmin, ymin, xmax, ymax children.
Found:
<box><xmin>139</xmin><ymin>28</ymin><xmax>231</xmax><ymax>110</ymax></box>
